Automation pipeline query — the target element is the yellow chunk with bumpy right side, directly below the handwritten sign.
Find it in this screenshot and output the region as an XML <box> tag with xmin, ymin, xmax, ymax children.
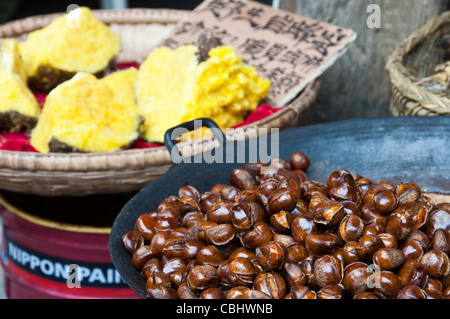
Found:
<box><xmin>135</xmin><ymin>45</ymin><xmax>270</xmax><ymax>142</ymax></box>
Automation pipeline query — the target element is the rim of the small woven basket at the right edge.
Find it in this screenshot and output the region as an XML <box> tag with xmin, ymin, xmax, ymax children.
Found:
<box><xmin>386</xmin><ymin>11</ymin><xmax>450</xmax><ymax>115</ymax></box>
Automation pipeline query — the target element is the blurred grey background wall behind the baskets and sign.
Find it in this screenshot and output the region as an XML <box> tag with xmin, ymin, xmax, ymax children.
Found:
<box><xmin>0</xmin><ymin>0</ymin><xmax>450</xmax><ymax>124</ymax></box>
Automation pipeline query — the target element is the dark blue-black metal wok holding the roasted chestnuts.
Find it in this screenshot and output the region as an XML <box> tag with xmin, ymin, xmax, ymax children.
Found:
<box><xmin>109</xmin><ymin>117</ymin><xmax>450</xmax><ymax>298</ymax></box>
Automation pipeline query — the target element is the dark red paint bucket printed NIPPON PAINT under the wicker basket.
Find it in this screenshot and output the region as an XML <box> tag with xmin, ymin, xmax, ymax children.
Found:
<box><xmin>0</xmin><ymin>192</ymin><xmax>138</xmax><ymax>299</ymax></box>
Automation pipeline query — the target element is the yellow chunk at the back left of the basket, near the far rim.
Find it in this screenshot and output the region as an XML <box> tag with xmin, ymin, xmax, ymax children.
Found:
<box><xmin>19</xmin><ymin>7</ymin><xmax>120</xmax><ymax>77</ymax></box>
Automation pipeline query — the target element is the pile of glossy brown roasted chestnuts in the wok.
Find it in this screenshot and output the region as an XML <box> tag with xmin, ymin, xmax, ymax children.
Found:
<box><xmin>123</xmin><ymin>152</ymin><xmax>450</xmax><ymax>299</ymax></box>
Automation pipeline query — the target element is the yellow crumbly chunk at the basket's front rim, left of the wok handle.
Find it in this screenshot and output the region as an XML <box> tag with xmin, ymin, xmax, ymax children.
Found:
<box><xmin>31</xmin><ymin>68</ymin><xmax>141</xmax><ymax>153</ymax></box>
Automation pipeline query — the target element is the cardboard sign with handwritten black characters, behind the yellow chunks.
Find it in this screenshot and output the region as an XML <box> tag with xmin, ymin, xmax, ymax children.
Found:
<box><xmin>159</xmin><ymin>0</ymin><xmax>356</xmax><ymax>107</ymax></box>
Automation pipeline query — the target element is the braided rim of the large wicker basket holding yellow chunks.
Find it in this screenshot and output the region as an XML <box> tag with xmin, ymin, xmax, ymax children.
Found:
<box><xmin>0</xmin><ymin>8</ymin><xmax>321</xmax><ymax>175</ymax></box>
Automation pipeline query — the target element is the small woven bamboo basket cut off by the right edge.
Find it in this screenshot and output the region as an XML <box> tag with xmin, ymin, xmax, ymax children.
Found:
<box><xmin>386</xmin><ymin>11</ymin><xmax>450</xmax><ymax>116</ymax></box>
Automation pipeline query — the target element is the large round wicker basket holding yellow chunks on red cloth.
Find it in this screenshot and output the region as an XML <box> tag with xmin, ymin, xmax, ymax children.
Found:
<box><xmin>0</xmin><ymin>9</ymin><xmax>320</xmax><ymax>196</ymax></box>
